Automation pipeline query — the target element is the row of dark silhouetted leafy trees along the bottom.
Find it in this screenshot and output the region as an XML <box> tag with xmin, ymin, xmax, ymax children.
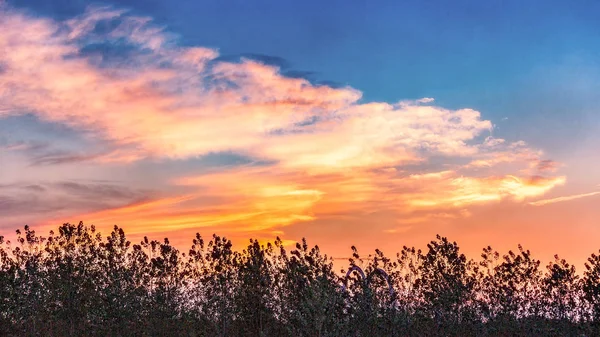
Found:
<box><xmin>0</xmin><ymin>223</ymin><xmax>600</xmax><ymax>336</ymax></box>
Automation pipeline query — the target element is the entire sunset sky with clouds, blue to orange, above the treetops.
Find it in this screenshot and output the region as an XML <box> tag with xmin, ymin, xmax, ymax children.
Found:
<box><xmin>0</xmin><ymin>0</ymin><xmax>600</xmax><ymax>266</ymax></box>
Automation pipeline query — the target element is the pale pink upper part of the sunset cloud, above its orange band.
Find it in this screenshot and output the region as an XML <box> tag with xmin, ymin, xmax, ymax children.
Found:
<box><xmin>0</xmin><ymin>9</ymin><xmax>491</xmax><ymax>166</ymax></box>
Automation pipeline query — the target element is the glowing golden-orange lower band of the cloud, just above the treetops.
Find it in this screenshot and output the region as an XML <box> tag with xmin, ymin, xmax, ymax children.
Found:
<box><xmin>39</xmin><ymin>168</ymin><xmax>564</xmax><ymax>242</ymax></box>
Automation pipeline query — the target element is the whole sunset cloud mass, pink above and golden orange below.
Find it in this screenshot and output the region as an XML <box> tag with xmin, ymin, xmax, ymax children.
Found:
<box><xmin>0</xmin><ymin>7</ymin><xmax>565</xmax><ymax>240</ymax></box>
